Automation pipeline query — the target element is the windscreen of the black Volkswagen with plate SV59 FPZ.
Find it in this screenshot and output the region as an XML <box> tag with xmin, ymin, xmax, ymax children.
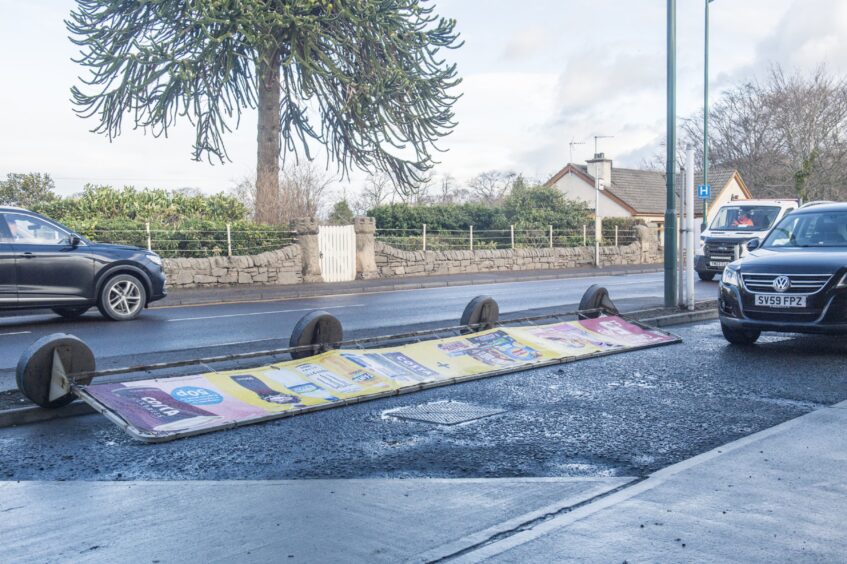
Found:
<box><xmin>763</xmin><ymin>211</ymin><xmax>847</xmax><ymax>249</ymax></box>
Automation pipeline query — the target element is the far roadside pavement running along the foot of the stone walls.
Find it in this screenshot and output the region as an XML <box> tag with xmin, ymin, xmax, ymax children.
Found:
<box><xmin>157</xmin><ymin>264</ymin><xmax>662</xmax><ymax>308</ymax></box>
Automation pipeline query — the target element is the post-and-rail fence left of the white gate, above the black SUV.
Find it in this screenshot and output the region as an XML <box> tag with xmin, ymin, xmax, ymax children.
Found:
<box><xmin>85</xmin><ymin>224</ymin><xmax>297</xmax><ymax>258</ymax></box>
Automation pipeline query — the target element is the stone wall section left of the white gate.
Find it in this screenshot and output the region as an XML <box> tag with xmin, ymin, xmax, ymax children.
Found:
<box><xmin>164</xmin><ymin>244</ymin><xmax>303</xmax><ymax>288</ymax></box>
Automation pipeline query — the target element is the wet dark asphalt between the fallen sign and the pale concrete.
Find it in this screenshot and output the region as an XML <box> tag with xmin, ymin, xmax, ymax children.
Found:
<box><xmin>0</xmin><ymin>322</ymin><xmax>847</xmax><ymax>480</ymax></box>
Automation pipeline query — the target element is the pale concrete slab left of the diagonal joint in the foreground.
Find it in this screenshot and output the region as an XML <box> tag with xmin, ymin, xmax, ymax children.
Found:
<box><xmin>0</xmin><ymin>478</ymin><xmax>630</xmax><ymax>564</ymax></box>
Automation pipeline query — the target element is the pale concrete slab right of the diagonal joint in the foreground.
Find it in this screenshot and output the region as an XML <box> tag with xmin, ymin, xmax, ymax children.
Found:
<box><xmin>458</xmin><ymin>402</ymin><xmax>847</xmax><ymax>564</ymax></box>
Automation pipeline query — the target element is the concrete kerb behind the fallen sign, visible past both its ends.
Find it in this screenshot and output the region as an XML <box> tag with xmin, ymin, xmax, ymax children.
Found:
<box><xmin>0</xmin><ymin>302</ymin><xmax>717</xmax><ymax>428</ymax></box>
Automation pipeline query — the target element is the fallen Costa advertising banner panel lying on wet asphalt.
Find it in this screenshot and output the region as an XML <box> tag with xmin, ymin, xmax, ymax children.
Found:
<box><xmin>76</xmin><ymin>316</ymin><xmax>680</xmax><ymax>442</ymax></box>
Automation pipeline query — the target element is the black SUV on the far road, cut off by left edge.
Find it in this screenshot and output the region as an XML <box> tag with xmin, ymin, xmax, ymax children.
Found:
<box><xmin>0</xmin><ymin>207</ymin><xmax>166</xmax><ymax>321</ymax></box>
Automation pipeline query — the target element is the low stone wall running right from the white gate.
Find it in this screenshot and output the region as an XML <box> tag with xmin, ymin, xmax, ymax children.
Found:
<box><xmin>375</xmin><ymin>241</ymin><xmax>662</xmax><ymax>278</ymax></box>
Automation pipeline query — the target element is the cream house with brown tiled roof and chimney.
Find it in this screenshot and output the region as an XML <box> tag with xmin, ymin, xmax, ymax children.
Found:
<box><xmin>544</xmin><ymin>153</ymin><xmax>752</xmax><ymax>225</ymax></box>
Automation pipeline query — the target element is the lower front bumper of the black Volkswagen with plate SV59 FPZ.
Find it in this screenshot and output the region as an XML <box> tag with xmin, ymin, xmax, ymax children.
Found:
<box><xmin>718</xmin><ymin>282</ymin><xmax>847</xmax><ymax>335</ymax></box>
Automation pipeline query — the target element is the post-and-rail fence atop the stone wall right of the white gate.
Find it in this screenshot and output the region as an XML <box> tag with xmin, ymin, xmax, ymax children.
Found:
<box><xmin>376</xmin><ymin>224</ymin><xmax>636</xmax><ymax>251</ymax></box>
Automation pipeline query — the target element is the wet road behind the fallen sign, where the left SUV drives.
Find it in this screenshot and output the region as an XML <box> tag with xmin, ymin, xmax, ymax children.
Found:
<box><xmin>0</xmin><ymin>273</ymin><xmax>716</xmax><ymax>390</ymax></box>
